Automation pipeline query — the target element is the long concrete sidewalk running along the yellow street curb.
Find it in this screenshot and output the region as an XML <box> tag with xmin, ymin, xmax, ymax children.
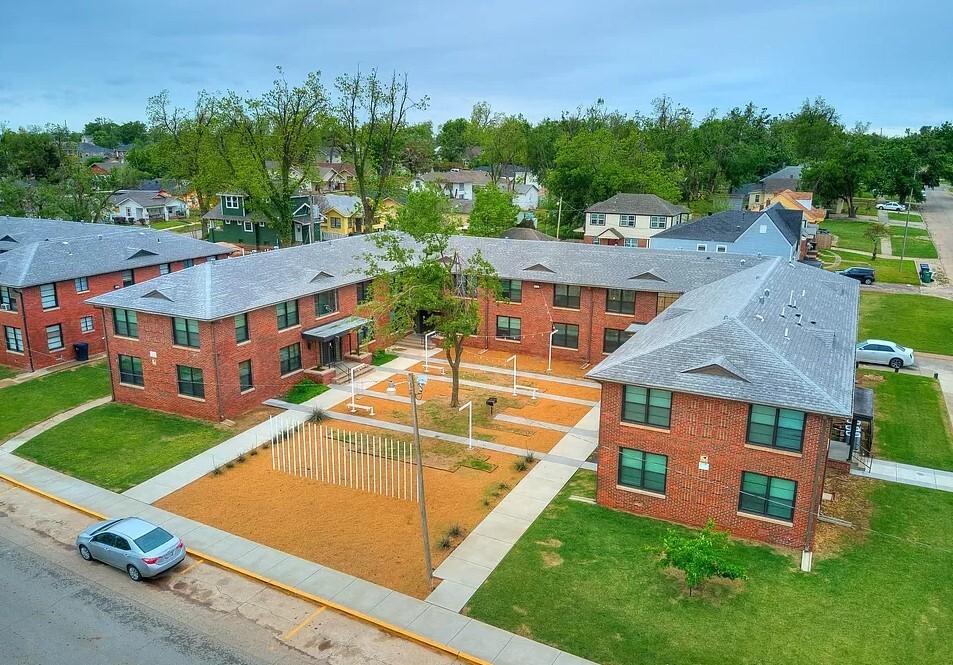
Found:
<box><xmin>0</xmin><ymin>451</ymin><xmax>590</xmax><ymax>665</ymax></box>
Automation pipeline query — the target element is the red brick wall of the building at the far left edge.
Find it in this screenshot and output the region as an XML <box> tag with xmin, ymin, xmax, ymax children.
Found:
<box><xmin>0</xmin><ymin>255</ymin><xmax>218</xmax><ymax>370</ymax></box>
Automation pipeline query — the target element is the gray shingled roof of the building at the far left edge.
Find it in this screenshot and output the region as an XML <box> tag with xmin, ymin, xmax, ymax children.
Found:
<box><xmin>0</xmin><ymin>217</ymin><xmax>228</xmax><ymax>288</ymax></box>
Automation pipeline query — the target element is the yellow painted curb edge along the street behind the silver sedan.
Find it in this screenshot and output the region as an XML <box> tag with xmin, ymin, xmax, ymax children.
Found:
<box><xmin>0</xmin><ymin>473</ymin><xmax>492</xmax><ymax>665</ymax></box>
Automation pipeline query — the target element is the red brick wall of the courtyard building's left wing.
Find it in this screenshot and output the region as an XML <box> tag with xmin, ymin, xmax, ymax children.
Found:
<box><xmin>100</xmin><ymin>285</ymin><xmax>384</xmax><ymax>421</ymax></box>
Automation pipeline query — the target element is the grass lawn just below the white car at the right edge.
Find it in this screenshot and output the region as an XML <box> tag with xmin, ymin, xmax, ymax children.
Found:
<box><xmin>857</xmin><ymin>370</ymin><xmax>953</xmax><ymax>471</ymax></box>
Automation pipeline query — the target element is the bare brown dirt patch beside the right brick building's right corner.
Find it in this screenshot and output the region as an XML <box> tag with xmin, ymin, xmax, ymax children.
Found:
<box><xmin>814</xmin><ymin>473</ymin><xmax>877</xmax><ymax>559</ymax></box>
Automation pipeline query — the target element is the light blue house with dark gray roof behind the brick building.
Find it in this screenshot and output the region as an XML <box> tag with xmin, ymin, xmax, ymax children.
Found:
<box><xmin>649</xmin><ymin>205</ymin><xmax>804</xmax><ymax>261</ymax></box>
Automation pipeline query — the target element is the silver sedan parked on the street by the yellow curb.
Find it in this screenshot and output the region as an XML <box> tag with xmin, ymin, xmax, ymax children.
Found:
<box><xmin>76</xmin><ymin>517</ymin><xmax>185</xmax><ymax>582</ymax></box>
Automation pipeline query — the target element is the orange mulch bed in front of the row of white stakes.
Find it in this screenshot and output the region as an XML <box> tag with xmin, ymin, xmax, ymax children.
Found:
<box><xmin>155</xmin><ymin>438</ymin><xmax>523</xmax><ymax>598</ymax></box>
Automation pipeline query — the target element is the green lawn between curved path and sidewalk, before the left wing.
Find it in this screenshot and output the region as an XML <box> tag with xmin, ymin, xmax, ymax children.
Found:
<box><xmin>15</xmin><ymin>403</ymin><xmax>233</xmax><ymax>492</ymax></box>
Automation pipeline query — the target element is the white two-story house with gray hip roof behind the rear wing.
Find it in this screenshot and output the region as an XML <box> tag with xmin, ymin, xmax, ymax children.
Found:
<box><xmin>576</xmin><ymin>193</ymin><xmax>691</xmax><ymax>247</ymax></box>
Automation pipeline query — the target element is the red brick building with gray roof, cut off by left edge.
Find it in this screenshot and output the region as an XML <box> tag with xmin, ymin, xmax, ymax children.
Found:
<box><xmin>0</xmin><ymin>217</ymin><xmax>227</xmax><ymax>371</ymax></box>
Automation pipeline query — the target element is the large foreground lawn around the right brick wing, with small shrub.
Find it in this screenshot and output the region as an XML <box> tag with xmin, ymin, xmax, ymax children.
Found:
<box><xmin>469</xmin><ymin>471</ymin><xmax>953</xmax><ymax>665</ymax></box>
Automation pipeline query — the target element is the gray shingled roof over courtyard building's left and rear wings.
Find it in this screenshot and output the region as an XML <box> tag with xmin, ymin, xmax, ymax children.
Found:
<box><xmin>89</xmin><ymin>236</ymin><xmax>761</xmax><ymax>320</ymax></box>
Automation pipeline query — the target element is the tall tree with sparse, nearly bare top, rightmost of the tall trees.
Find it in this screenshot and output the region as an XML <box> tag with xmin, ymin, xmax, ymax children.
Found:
<box><xmin>332</xmin><ymin>69</ymin><xmax>428</xmax><ymax>230</ymax></box>
